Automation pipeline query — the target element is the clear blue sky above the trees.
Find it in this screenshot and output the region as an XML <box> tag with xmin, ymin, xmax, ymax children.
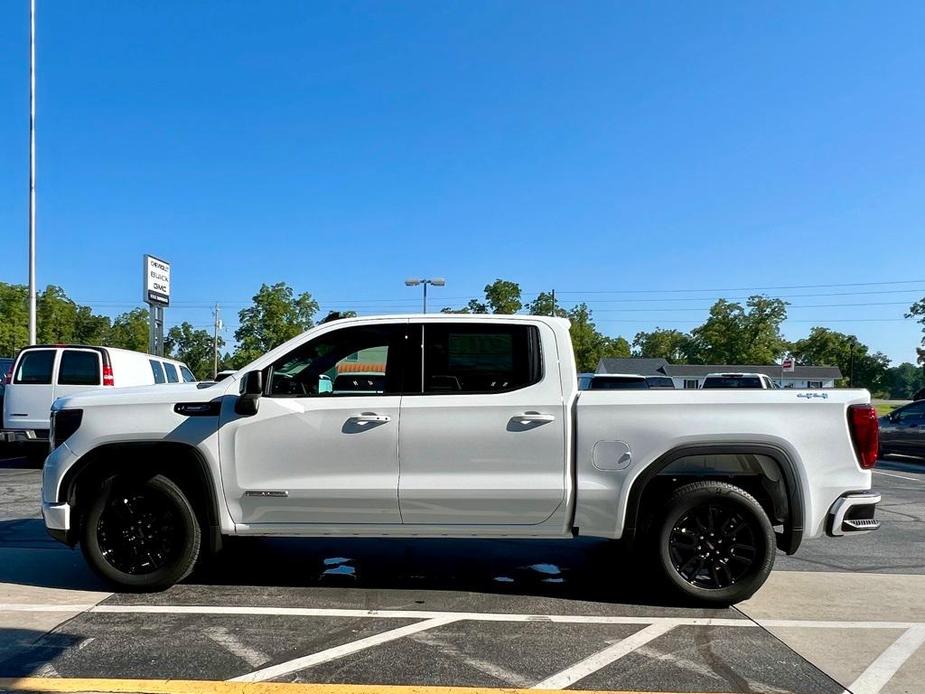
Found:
<box><xmin>0</xmin><ymin>0</ymin><xmax>925</xmax><ymax>361</ymax></box>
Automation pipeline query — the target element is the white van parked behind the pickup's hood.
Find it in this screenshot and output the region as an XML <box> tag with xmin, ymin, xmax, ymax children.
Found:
<box><xmin>0</xmin><ymin>345</ymin><xmax>196</xmax><ymax>441</ymax></box>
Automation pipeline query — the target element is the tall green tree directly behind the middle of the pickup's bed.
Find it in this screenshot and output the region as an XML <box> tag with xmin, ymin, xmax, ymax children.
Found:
<box><xmin>690</xmin><ymin>295</ymin><xmax>787</xmax><ymax>364</ymax></box>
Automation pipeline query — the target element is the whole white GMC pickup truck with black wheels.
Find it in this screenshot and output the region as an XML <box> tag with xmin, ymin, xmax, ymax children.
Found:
<box><xmin>42</xmin><ymin>314</ymin><xmax>880</xmax><ymax>603</ymax></box>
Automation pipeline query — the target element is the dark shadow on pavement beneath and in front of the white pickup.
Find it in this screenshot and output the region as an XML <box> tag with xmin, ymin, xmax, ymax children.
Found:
<box><xmin>0</xmin><ymin>518</ymin><xmax>684</xmax><ymax>607</ymax></box>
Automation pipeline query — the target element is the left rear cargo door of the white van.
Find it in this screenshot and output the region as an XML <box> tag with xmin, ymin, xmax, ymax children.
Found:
<box><xmin>3</xmin><ymin>348</ymin><xmax>58</xmax><ymax>431</ymax></box>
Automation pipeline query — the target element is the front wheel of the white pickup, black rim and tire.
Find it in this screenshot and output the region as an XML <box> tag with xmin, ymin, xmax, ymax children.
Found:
<box><xmin>80</xmin><ymin>475</ymin><xmax>202</xmax><ymax>591</ymax></box>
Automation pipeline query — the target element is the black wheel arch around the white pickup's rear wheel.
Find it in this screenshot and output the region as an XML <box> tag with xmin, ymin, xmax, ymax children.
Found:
<box><xmin>623</xmin><ymin>442</ymin><xmax>805</xmax><ymax>554</ymax></box>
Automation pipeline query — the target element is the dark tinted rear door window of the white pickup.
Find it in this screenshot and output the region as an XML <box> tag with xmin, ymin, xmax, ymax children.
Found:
<box><xmin>423</xmin><ymin>323</ymin><xmax>543</xmax><ymax>393</ymax></box>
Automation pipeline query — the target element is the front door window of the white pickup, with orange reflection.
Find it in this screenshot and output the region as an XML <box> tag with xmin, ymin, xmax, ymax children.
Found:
<box><xmin>268</xmin><ymin>324</ymin><xmax>407</xmax><ymax>397</ymax></box>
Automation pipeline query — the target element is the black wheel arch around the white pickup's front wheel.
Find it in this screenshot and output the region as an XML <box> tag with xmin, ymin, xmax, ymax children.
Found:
<box><xmin>58</xmin><ymin>441</ymin><xmax>222</xmax><ymax>552</ymax></box>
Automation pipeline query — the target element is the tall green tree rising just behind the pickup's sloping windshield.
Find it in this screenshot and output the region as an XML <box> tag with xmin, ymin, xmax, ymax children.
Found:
<box><xmin>234</xmin><ymin>282</ymin><xmax>318</xmax><ymax>368</ymax></box>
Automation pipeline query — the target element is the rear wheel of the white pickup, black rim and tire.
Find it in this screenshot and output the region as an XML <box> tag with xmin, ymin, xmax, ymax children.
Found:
<box><xmin>652</xmin><ymin>481</ymin><xmax>776</xmax><ymax>605</ymax></box>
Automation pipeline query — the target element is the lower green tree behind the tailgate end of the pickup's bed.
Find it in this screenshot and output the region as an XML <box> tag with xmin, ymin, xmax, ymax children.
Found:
<box><xmin>790</xmin><ymin>326</ymin><xmax>890</xmax><ymax>394</ymax></box>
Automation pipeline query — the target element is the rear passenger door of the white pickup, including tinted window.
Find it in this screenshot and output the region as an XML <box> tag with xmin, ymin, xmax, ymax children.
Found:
<box><xmin>399</xmin><ymin>321</ymin><xmax>567</xmax><ymax>525</ymax></box>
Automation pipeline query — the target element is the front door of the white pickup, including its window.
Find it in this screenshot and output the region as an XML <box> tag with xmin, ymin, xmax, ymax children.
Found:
<box><xmin>219</xmin><ymin>322</ymin><xmax>408</xmax><ymax>532</ymax></box>
